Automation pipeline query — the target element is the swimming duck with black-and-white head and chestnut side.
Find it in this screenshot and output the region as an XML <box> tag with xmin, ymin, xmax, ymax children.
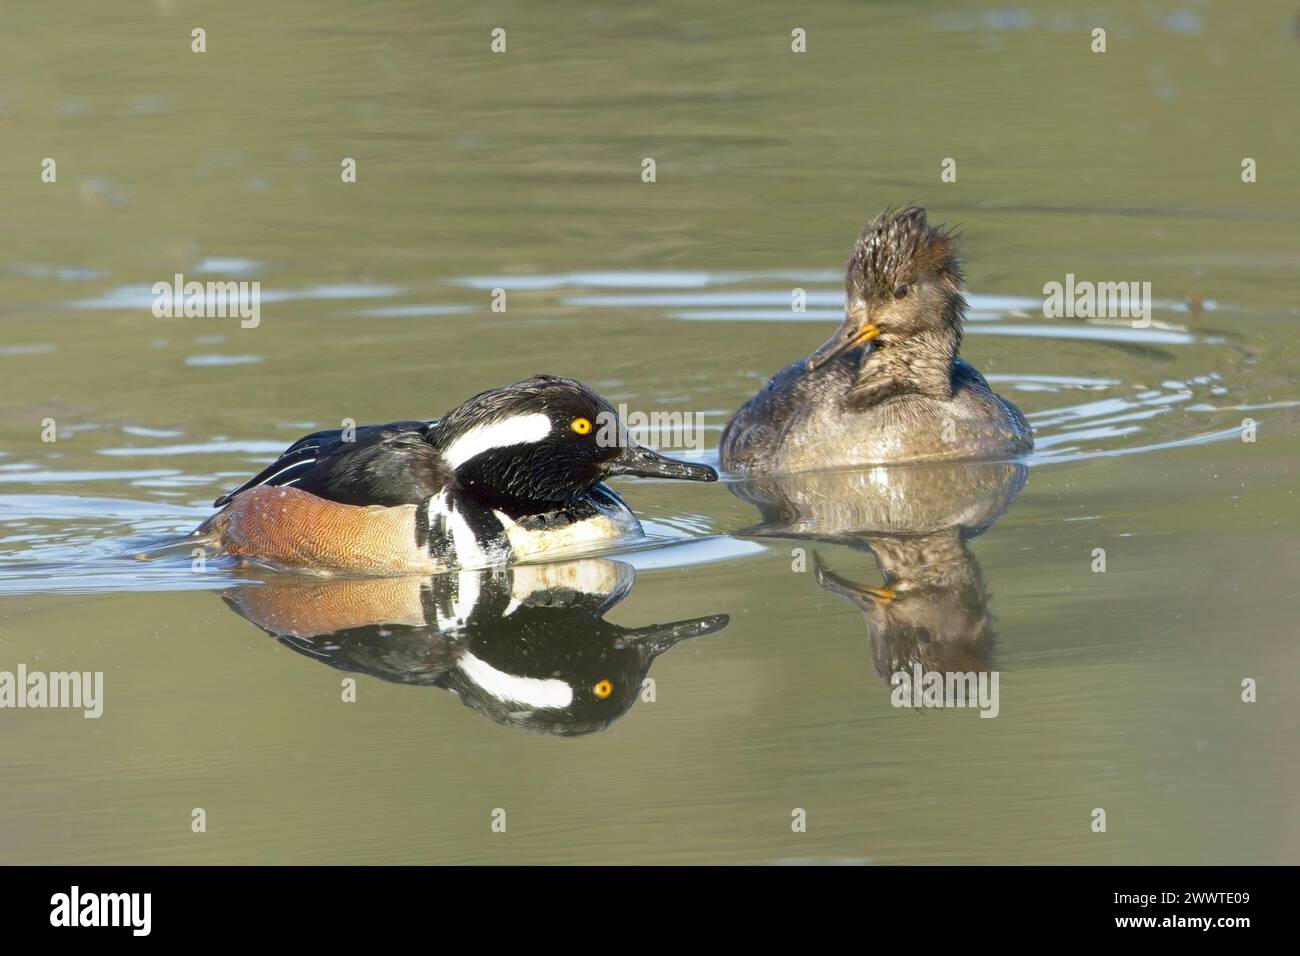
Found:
<box><xmin>194</xmin><ymin>375</ymin><xmax>718</xmax><ymax>574</ymax></box>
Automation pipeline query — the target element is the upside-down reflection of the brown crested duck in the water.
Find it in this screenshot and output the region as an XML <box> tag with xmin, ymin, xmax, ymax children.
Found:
<box><xmin>731</xmin><ymin>462</ymin><xmax>1027</xmax><ymax>702</ymax></box>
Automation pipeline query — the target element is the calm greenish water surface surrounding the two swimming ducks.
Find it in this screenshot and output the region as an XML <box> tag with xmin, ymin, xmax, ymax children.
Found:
<box><xmin>0</xmin><ymin>0</ymin><xmax>1300</xmax><ymax>864</ymax></box>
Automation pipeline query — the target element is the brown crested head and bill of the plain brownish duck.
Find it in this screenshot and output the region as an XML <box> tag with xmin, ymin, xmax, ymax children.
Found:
<box><xmin>806</xmin><ymin>206</ymin><xmax>966</xmax><ymax>371</ymax></box>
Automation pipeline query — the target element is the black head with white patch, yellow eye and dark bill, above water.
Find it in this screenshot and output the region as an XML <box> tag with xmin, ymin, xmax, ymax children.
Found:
<box><xmin>432</xmin><ymin>375</ymin><xmax>718</xmax><ymax>506</ymax></box>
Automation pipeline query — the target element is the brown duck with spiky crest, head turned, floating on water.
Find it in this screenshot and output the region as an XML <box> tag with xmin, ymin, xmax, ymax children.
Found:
<box><xmin>722</xmin><ymin>207</ymin><xmax>1034</xmax><ymax>473</ymax></box>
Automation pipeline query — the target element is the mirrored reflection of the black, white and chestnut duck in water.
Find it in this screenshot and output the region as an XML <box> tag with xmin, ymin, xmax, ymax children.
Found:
<box><xmin>222</xmin><ymin>559</ymin><xmax>729</xmax><ymax>736</ymax></box>
